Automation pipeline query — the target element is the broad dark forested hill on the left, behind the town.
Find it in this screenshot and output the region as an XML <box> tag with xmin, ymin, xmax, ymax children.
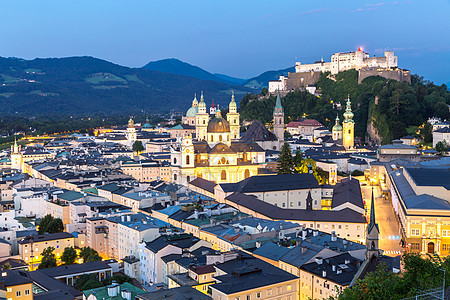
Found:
<box><xmin>0</xmin><ymin>57</ymin><xmax>251</xmax><ymax>116</ymax></box>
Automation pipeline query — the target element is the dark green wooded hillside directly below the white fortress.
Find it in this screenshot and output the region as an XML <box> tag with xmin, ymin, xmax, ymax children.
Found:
<box><xmin>240</xmin><ymin>70</ymin><xmax>450</xmax><ymax>143</ymax></box>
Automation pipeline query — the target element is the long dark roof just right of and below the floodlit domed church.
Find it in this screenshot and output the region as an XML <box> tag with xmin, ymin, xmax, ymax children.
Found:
<box><xmin>236</xmin><ymin>173</ymin><xmax>319</xmax><ymax>193</ymax></box>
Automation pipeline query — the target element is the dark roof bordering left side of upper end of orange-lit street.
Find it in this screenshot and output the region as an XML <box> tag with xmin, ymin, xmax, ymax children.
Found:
<box><xmin>331</xmin><ymin>178</ymin><xmax>364</xmax><ymax>209</ymax></box>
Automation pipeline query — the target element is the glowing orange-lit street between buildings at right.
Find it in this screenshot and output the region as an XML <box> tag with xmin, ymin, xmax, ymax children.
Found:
<box><xmin>361</xmin><ymin>186</ymin><xmax>403</xmax><ymax>256</ymax></box>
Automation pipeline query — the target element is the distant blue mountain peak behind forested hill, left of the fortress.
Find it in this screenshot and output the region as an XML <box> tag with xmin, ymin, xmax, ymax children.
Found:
<box><xmin>143</xmin><ymin>58</ymin><xmax>245</xmax><ymax>85</ymax></box>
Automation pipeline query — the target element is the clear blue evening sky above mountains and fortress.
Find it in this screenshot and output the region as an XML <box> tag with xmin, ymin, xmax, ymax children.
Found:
<box><xmin>0</xmin><ymin>0</ymin><xmax>450</xmax><ymax>84</ymax></box>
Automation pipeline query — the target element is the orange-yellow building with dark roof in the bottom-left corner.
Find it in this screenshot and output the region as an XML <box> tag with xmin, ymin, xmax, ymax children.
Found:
<box><xmin>0</xmin><ymin>270</ymin><xmax>33</xmax><ymax>300</ymax></box>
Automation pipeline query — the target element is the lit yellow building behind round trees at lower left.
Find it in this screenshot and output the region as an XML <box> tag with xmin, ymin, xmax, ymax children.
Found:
<box><xmin>17</xmin><ymin>232</ymin><xmax>75</xmax><ymax>269</ymax></box>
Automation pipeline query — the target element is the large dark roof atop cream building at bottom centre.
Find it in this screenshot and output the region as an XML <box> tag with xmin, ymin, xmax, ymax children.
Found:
<box><xmin>210</xmin><ymin>252</ymin><xmax>298</xmax><ymax>295</ymax></box>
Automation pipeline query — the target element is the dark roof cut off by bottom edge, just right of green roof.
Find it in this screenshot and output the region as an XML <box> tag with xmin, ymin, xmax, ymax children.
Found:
<box><xmin>136</xmin><ymin>286</ymin><xmax>212</xmax><ymax>300</ymax></box>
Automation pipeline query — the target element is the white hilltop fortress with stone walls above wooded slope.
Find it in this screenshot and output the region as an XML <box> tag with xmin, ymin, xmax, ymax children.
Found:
<box><xmin>269</xmin><ymin>48</ymin><xmax>411</xmax><ymax>93</ymax></box>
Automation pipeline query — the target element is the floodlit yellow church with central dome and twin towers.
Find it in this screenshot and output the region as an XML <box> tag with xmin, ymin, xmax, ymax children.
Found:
<box><xmin>171</xmin><ymin>94</ymin><xmax>265</xmax><ymax>184</ymax></box>
